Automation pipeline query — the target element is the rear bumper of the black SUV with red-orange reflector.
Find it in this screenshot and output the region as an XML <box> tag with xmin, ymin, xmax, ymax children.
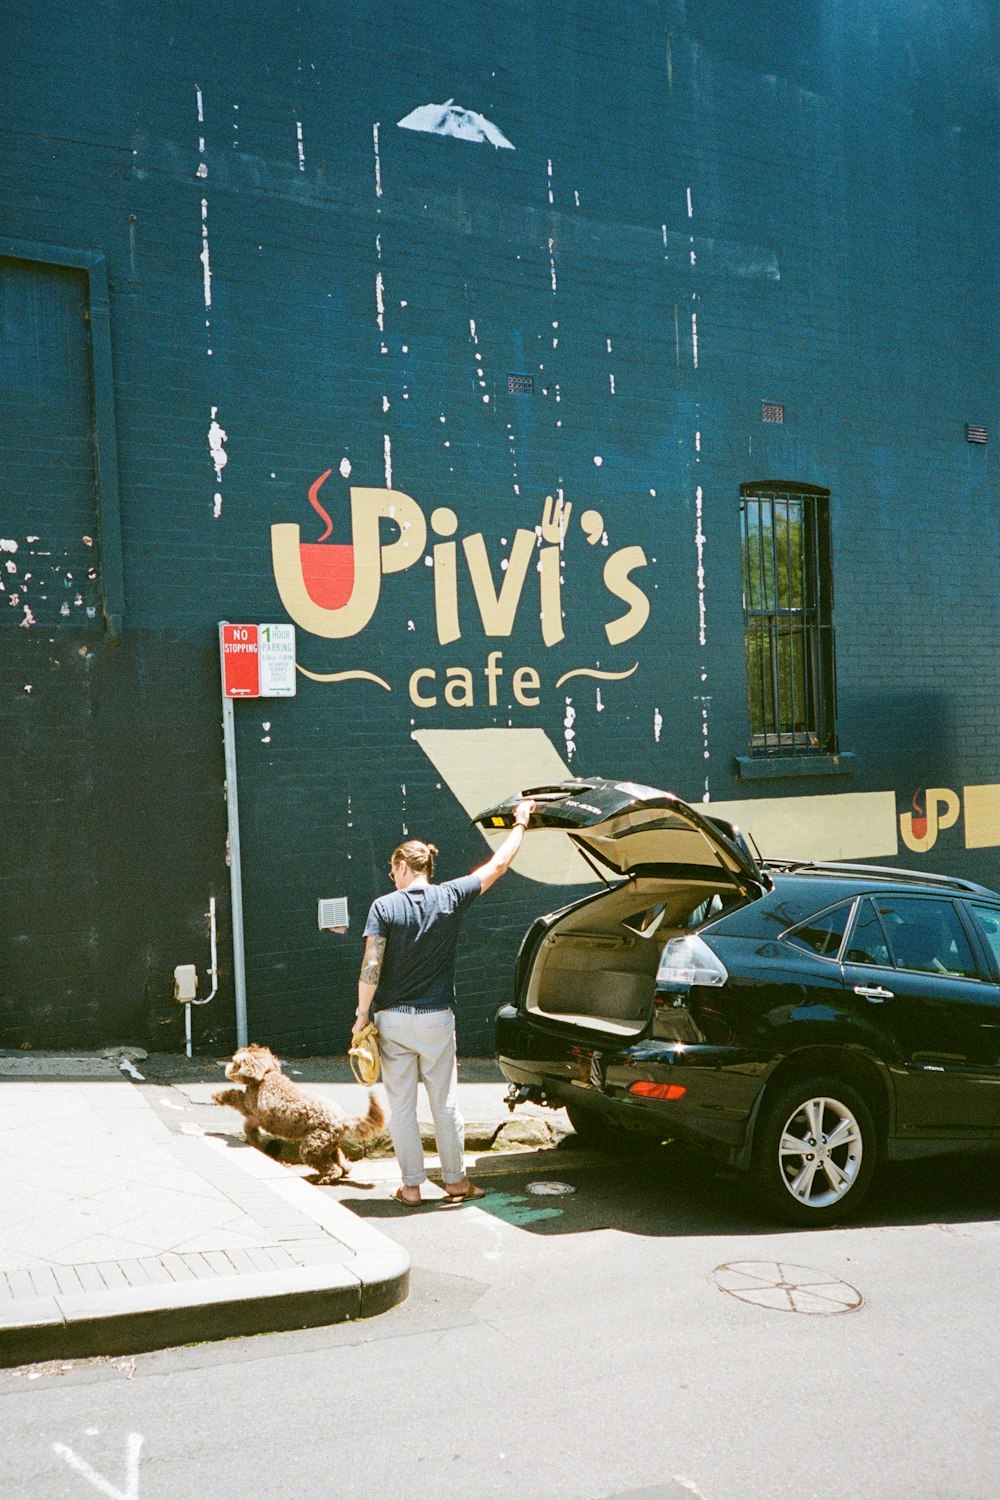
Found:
<box><xmin>496</xmin><ymin>1005</ymin><xmax>766</xmax><ymax>1164</ymax></box>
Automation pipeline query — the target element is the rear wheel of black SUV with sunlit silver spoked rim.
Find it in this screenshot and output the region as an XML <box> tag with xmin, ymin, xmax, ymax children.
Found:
<box><xmin>751</xmin><ymin>1076</ymin><xmax>877</xmax><ymax>1227</ymax></box>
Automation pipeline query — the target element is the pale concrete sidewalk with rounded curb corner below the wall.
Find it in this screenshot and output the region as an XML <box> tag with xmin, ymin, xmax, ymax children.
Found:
<box><xmin>0</xmin><ymin>1053</ymin><xmax>550</xmax><ymax>1367</ymax></box>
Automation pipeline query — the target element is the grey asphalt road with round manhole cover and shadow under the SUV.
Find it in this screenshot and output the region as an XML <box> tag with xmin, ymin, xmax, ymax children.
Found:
<box><xmin>0</xmin><ymin>1143</ymin><xmax>1000</xmax><ymax>1500</ymax></box>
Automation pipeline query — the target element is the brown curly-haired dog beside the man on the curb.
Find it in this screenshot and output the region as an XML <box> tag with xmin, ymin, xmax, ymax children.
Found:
<box><xmin>213</xmin><ymin>1043</ymin><xmax>385</xmax><ymax>1182</ymax></box>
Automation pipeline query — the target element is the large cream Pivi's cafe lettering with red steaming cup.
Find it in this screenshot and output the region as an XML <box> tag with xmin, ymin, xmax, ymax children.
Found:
<box><xmin>271</xmin><ymin>470</ymin><xmax>649</xmax><ymax>710</ymax></box>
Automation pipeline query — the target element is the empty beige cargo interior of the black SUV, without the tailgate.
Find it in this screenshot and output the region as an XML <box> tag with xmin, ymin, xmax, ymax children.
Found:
<box><xmin>520</xmin><ymin>875</ymin><xmax>744</xmax><ymax>1038</ymax></box>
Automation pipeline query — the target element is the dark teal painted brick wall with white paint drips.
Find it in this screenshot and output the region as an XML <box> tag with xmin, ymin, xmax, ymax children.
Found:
<box><xmin>0</xmin><ymin>0</ymin><xmax>1000</xmax><ymax>1053</ymax></box>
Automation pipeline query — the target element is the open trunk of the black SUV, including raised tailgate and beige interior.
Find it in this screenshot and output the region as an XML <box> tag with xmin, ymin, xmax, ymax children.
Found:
<box><xmin>475</xmin><ymin>777</ymin><xmax>768</xmax><ymax>1038</ymax></box>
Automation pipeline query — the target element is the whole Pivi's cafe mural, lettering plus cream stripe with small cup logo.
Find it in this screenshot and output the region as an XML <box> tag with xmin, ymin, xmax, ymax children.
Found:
<box><xmin>271</xmin><ymin>470</ymin><xmax>1000</xmax><ymax>884</ymax></box>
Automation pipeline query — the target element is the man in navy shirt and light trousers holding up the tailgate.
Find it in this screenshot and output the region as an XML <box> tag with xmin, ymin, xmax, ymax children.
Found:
<box><xmin>354</xmin><ymin>801</ymin><xmax>535</xmax><ymax>1208</ymax></box>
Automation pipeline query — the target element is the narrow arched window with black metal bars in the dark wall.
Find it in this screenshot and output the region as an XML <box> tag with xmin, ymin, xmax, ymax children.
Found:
<box><xmin>739</xmin><ymin>480</ymin><xmax>837</xmax><ymax>756</ymax></box>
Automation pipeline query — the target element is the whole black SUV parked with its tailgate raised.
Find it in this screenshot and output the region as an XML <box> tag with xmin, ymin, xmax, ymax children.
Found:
<box><xmin>477</xmin><ymin>777</ymin><xmax>1000</xmax><ymax>1224</ymax></box>
